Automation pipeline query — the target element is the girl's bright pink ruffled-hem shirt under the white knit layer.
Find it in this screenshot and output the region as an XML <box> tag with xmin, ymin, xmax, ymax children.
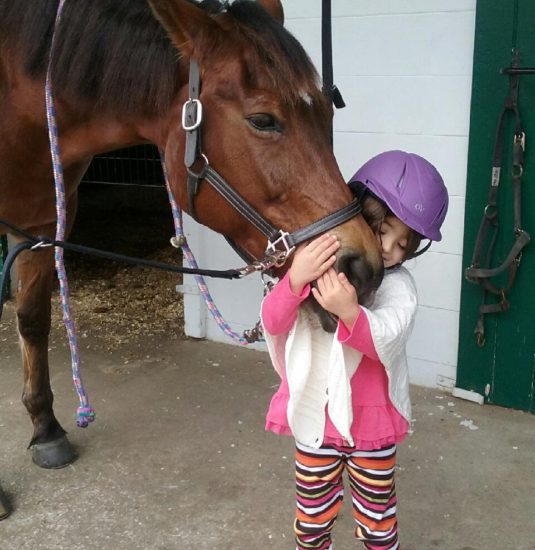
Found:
<box><xmin>262</xmin><ymin>275</ymin><xmax>409</xmax><ymax>450</ymax></box>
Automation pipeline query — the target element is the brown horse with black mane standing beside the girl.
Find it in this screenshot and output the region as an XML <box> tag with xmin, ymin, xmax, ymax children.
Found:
<box><xmin>0</xmin><ymin>0</ymin><xmax>382</xmax><ymax>467</ymax></box>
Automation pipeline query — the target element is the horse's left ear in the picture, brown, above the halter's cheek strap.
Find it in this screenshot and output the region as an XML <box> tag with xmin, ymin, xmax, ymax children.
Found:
<box><xmin>148</xmin><ymin>0</ymin><xmax>221</xmax><ymax>56</ymax></box>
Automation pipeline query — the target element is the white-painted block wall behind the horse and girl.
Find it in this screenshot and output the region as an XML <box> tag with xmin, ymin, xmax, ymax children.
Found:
<box><xmin>181</xmin><ymin>0</ymin><xmax>476</xmax><ymax>386</ymax></box>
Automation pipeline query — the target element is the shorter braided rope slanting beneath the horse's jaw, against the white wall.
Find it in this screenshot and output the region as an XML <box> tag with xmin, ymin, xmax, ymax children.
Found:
<box><xmin>160</xmin><ymin>156</ymin><xmax>249</xmax><ymax>346</ymax></box>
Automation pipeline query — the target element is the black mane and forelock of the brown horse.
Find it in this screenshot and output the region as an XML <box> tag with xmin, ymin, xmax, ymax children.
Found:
<box><xmin>0</xmin><ymin>0</ymin><xmax>324</xmax><ymax>115</ymax></box>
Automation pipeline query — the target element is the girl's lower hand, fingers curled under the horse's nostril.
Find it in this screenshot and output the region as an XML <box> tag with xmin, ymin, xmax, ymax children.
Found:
<box><xmin>312</xmin><ymin>268</ymin><xmax>360</xmax><ymax>330</ymax></box>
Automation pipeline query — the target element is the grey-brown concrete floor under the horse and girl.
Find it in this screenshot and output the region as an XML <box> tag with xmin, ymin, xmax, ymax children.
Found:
<box><xmin>0</xmin><ymin>312</ymin><xmax>535</xmax><ymax>550</ymax></box>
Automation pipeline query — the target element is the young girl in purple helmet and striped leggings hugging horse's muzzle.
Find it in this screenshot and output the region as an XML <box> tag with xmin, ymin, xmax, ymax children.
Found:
<box><xmin>261</xmin><ymin>151</ymin><xmax>448</xmax><ymax>550</ymax></box>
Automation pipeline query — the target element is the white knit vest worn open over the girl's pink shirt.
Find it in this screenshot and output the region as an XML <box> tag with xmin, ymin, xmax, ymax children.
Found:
<box><xmin>264</xmin><ymin>267</ymin><xmax>417</xmax><ymax>448</ymax></box>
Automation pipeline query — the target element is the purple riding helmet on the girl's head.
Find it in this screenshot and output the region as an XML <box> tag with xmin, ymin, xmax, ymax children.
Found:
<box><xmin>349</xmin><ymin>151</ymin><xmax>448</xmax><ymax>241</ymax></box>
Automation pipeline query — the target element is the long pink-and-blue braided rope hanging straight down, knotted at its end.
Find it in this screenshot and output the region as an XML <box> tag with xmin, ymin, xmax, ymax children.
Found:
<box><xmin>45</xmin><ymin>0</ymin><xmax>95</xmax><ymax>428</ymax></box>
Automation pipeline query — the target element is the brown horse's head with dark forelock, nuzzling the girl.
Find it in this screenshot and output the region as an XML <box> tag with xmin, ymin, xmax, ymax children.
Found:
<box><xmin>149</xmin><ymin>0</ymin><xmax>383</xmax><ymax>331</ymax></box>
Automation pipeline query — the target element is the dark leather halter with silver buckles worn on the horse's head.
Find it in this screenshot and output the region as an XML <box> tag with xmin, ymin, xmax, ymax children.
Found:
<box><xmin>182</xmin><ymin>59</ymin><xmax>362</xmax><ymax>267</ymax></box>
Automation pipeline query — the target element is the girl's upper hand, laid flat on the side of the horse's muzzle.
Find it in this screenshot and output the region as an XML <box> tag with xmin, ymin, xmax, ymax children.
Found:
<box><xmin>289</xmin><ymin>233</ymin><xmax>340</xmax><ymax>294</ymax></box>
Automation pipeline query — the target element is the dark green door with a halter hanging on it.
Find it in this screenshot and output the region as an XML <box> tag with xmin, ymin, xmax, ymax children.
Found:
<box><xmin>457</xmin><ymin>0</ymin><xmax>535</xmax><ymax>412</ymax></box>
